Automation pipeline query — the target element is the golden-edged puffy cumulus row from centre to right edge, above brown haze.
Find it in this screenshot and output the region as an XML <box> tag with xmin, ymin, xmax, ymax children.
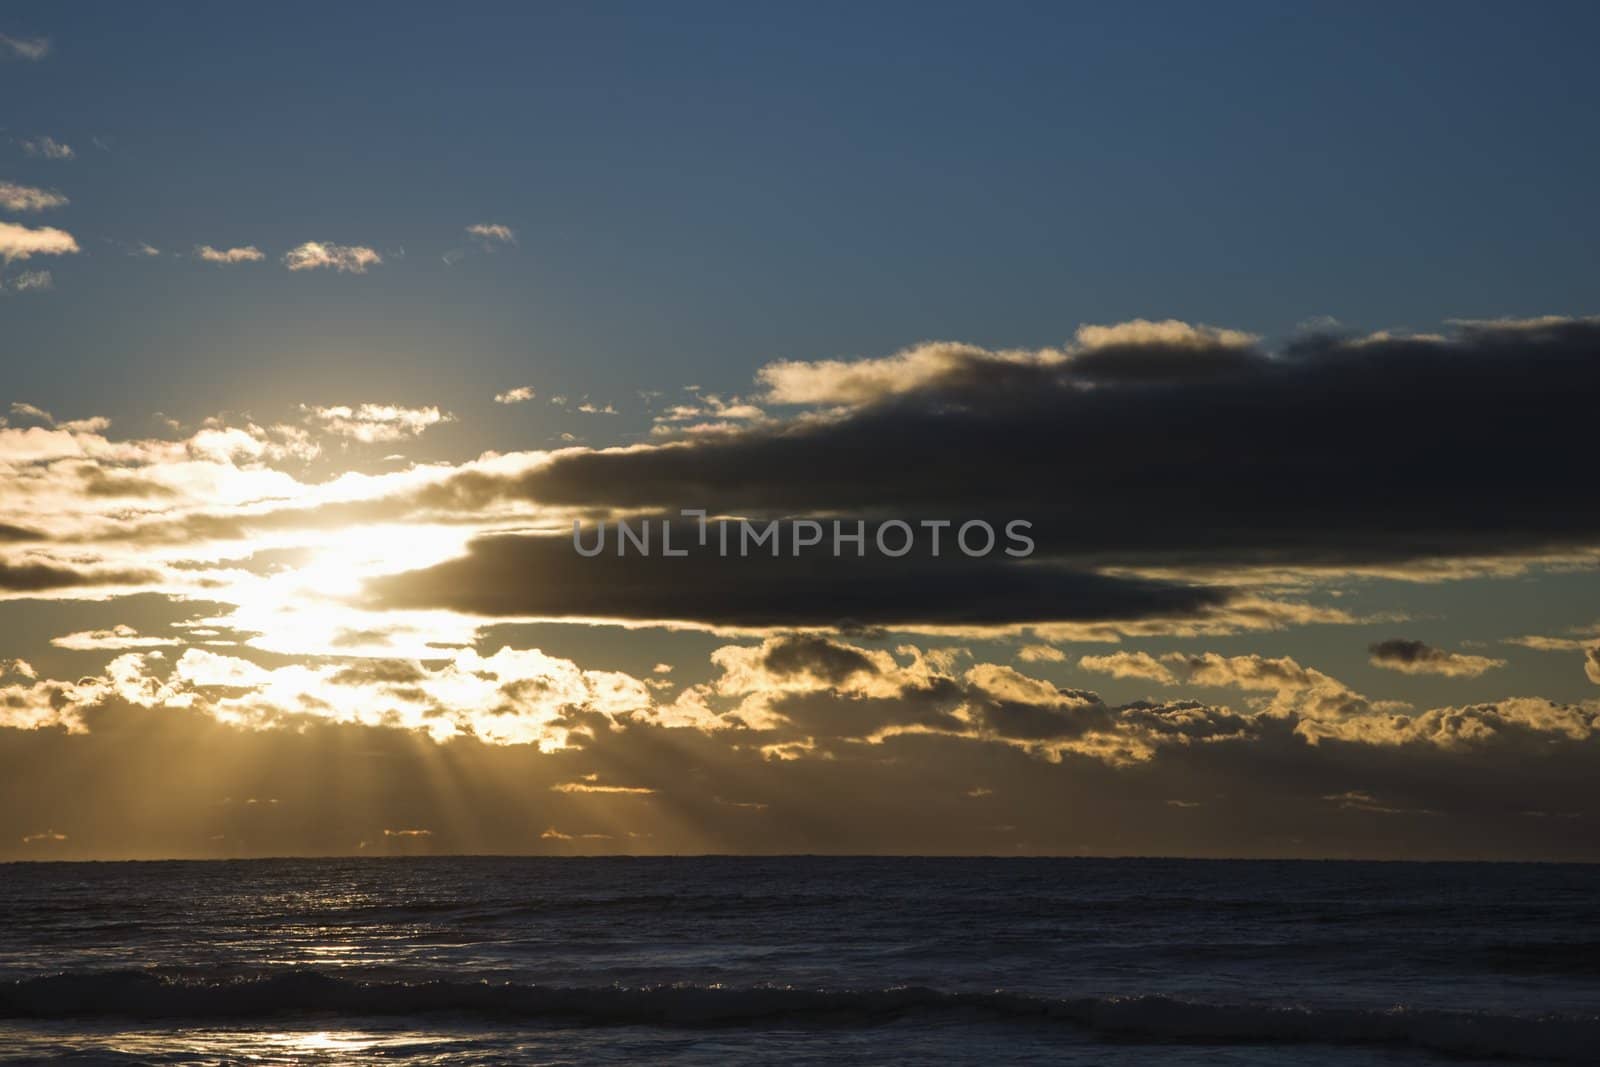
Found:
<box><xmin>675</xmin><ymin>637</ymin><xmax>1600</xmax><ymax>766</ymax></box>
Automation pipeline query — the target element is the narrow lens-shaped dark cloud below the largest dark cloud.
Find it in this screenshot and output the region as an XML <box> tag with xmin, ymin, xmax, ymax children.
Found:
<box><xmin>370</xmin><ymin>526</ymin><xmax>1227</xmax><ymax>627</ymax></box>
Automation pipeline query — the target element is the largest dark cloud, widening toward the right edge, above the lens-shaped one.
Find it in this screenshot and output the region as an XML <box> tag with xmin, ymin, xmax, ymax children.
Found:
<box><xmin>460</xmin><ymin>320</ymin><xmax>1600</xmax><ymax>565</ymax></box>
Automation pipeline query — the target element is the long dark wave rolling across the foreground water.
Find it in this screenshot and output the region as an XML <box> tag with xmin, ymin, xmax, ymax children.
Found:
<box><xmin>0</xmin><ymin>971</ymin><xmax>1600</xmax><ymax>1061</ymax></box>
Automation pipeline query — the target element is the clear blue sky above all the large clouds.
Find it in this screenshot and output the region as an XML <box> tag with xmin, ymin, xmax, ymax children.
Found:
<box><xmin>0</xmin><ymin>3</ymin><xmax>1600</xmax><ymax>434</ymax></box>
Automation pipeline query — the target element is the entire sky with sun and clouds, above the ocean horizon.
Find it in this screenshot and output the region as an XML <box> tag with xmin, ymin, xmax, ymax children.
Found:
<box><xmin>0</xmin><ymin>3</ymin><xmax>1600</xmax><ymax>859</ymax></box>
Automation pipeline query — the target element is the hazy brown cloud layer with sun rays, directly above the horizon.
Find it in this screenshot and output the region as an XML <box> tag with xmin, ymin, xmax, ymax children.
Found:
<box><xmin>0</xmin><ymin>681</ymin><xmax>1600</xmax><ymax>861</ymax></box>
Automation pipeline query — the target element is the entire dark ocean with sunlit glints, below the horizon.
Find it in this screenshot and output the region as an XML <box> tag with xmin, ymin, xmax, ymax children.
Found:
<box><xmin>0</xmin><ymin>857</ymin><xmax>1600</xmax><ymax>1064</ymax></box>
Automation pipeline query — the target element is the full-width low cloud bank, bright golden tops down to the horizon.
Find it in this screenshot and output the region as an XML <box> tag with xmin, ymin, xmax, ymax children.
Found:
<box><xmin>0</xmin><ymin>633</ymin><xmax>1600</xmax><ymax>856</ymax></box>
